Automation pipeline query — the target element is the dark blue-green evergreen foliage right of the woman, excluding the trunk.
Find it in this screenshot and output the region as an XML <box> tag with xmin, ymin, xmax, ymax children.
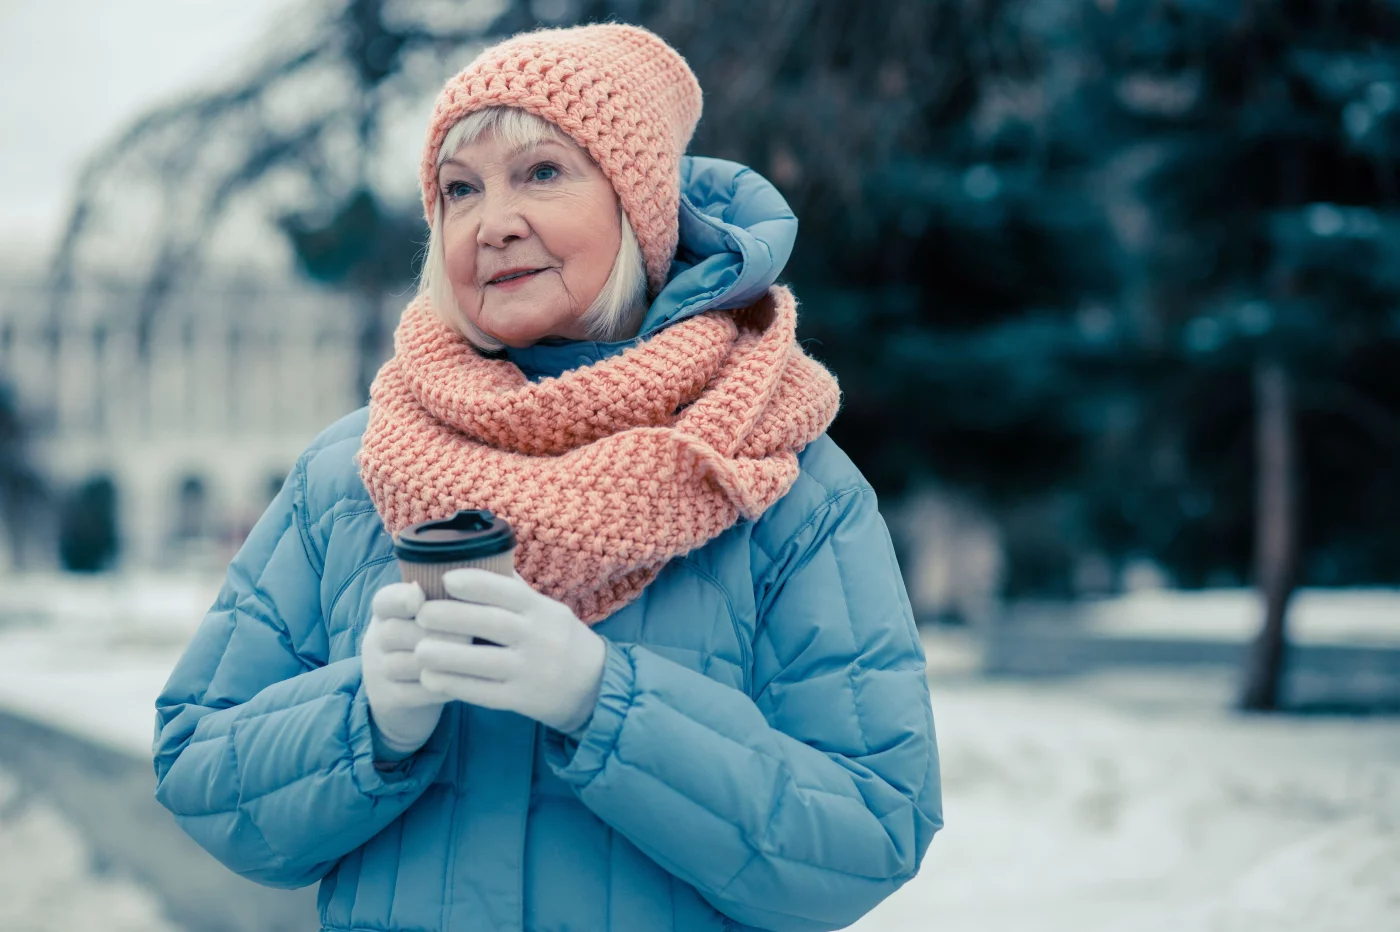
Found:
<box><xmin>649</xmin><ymin>0</ymin><xmax>1400</xmax><ymax>592</ymax></box>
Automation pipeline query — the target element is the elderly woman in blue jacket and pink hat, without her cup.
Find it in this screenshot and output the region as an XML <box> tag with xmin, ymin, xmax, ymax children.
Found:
<box><xmin>154</xmin><ymin>25</ymin><xmax>942</xmax><ymax>932</ymax></box>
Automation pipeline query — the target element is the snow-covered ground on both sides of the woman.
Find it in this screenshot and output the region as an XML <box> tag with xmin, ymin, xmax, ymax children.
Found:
<box><xmin>0</xmin><ymin>565</ymin><xmax>1400</xmax><ymax>932</ymax></box>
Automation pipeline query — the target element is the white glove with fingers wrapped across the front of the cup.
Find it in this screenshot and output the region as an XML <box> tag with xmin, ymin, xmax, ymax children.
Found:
<box><xmin>414</xmin><ymin>568</ymin><xmax>608</xmax><ymax>735</ymax></box>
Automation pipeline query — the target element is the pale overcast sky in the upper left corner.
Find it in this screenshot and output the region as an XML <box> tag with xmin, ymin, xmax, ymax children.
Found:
<box><xmin>0</xmin><ymin>0</ymin><xmax>307</xmax><ymax>262</ymax></box>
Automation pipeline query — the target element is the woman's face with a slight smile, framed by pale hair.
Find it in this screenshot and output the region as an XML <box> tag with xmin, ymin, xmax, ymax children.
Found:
<box><xmin>438</xmin><ymin>133</ymin><xmax>622</xmax><ymax>348</ymax></box>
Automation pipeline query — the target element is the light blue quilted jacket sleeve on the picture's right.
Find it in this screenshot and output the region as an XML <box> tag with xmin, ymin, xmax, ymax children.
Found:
<box><xmin>549</xmin><ymin>487</ymin><xmax>942</xmax><ymax>931</ymax></box>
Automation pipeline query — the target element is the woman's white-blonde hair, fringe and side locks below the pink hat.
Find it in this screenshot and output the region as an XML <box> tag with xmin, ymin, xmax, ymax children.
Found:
<box><xmin>419</xmin><ymin>106</ymin><xmax>647</xmax><ymax>353</ymax></box>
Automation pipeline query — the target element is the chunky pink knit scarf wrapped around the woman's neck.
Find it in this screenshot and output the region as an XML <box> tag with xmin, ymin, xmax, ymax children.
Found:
<box><xmin>356</xmin><ymin>287</ymin><xmax>840</xmax><ymax>624</ymax></box>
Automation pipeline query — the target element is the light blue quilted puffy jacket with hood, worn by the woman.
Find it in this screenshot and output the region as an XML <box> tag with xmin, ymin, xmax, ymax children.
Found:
<box><xmin>154</xmin><ymin>158</ymin><xmax>942</xmax><ymax>932</ymax></box>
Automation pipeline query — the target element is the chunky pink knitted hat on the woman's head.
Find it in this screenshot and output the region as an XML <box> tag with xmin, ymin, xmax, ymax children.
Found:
<box><xmin>420</xmin><ymin>22</ymin><xmax>700</xmax><ymax>291</ymax></box>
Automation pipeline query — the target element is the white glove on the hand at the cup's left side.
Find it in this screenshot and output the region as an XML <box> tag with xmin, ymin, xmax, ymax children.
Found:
<box><xmin>360</xmin><ymin>582</ymin><xmax>451</xmax><ymax>760</ymax></box>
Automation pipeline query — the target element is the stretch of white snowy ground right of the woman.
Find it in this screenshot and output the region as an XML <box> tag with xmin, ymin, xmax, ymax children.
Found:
<box><xmin>853</xmin><ymin>673</ymin><xmax>1400</xmax><ymax>932</ymax></box>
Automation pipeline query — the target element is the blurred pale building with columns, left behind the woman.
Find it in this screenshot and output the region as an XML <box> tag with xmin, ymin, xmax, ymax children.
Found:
<box><xmin>0</xmin><ymin>270</ymin><xmax>363</xmax><ymax>570</ymax></box>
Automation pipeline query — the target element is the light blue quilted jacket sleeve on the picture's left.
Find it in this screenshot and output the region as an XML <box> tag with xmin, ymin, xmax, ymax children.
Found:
<box><xmin>154</xmin><ymin>455</ymin><xmax>448</xmax><ymax>887</ymax></box>
